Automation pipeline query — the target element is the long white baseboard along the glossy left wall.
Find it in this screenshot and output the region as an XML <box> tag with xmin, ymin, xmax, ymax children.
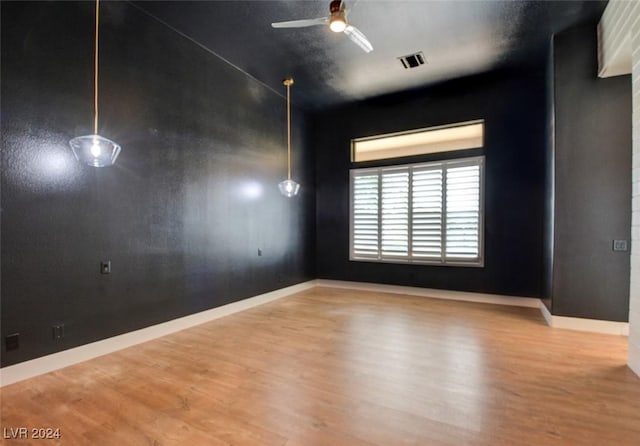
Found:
<box><xmin>0</xmin><ymin>280</ymin><xmax>315</xmax><ymax>387</ymax></box>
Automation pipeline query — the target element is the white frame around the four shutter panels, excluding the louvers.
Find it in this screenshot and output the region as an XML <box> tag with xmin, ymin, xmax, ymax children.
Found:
<box><xmin>349</xmin><ymin>155</ymin><xmax>485</xmax><ymax>268</ymax></box>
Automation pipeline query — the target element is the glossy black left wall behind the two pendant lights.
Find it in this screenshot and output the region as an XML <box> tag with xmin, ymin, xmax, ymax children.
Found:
<box><xmin>1</xmin><ymin>1</ymin><xmax>315</xmax><ymax>366</ymax></box>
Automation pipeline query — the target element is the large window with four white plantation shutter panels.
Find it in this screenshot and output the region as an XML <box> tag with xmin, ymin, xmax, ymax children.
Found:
<box><xmin>350</xmin><ymin>156</ymin><xmax>484</xmax><ymax>266</ymax></box>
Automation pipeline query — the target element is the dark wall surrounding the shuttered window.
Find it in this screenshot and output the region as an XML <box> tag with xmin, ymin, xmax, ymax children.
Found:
<box><xmin>313</xmin><ymin>69</ymin><xmax>546</xmax><ymax>297</ymax></box>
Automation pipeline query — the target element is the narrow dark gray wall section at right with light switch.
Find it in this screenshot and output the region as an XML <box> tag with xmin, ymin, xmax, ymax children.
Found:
<box><xmin>552</xmin><ymin>24</ymin><xmax>631</xmax><ymax>321</ymax></box>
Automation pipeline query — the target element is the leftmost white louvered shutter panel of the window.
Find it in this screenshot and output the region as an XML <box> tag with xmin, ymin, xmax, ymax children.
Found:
<box><xmin>352</xmin><ymin>172</ymin><xmax>379</xmax><ymax>258</ymax></box>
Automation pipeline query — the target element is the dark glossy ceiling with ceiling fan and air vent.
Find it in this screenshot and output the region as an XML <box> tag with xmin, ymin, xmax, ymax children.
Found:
<box><xmin>135</xmin><ymin>0</ymin><xmax>606</xmax><ymax>109</ymax></box>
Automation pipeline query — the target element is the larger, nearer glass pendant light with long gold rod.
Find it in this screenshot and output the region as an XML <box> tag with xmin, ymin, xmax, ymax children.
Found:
<box><xmin>69</xmin><ymin>0</ymin><xmax>120</xmax><ymax>167</ymax></box>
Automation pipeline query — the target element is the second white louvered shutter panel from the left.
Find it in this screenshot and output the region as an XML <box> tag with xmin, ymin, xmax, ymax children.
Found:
<box><xmin>381</xmin><ymin>169</ymin><xmax>409</xmax><ymax>257</ymax></box>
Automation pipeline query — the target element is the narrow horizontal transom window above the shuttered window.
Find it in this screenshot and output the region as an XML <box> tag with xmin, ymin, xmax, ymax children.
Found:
<box><xmin>351</xmin><ymin>120</ymin><xmax>484</xmax><ymax>162</ymax></box>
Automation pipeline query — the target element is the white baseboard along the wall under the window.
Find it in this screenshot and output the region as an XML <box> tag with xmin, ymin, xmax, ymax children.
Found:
<box><xmin>316</xmin><ymin>279</ymin><xmax>541</xmax><ymax>308</ymax></box>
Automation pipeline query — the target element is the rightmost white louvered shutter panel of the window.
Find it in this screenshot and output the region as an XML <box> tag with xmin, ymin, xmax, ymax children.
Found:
<box><xmin>446</xmin><ymin>165</ymin><xmax>480</xmax><ymax>259</ymax></box>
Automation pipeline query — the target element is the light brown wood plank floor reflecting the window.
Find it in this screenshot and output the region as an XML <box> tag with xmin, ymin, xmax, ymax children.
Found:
<box><xmin>0</xmin><ymin>288</ymin><xmax>640</xmax><ymax>446</ymax></box>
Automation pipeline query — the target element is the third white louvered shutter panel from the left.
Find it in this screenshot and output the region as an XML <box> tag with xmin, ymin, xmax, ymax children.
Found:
<box><xmin>411</xmin><ymin>166</ymin><xmax>442</xmax><ymax>260</ymax></box>
